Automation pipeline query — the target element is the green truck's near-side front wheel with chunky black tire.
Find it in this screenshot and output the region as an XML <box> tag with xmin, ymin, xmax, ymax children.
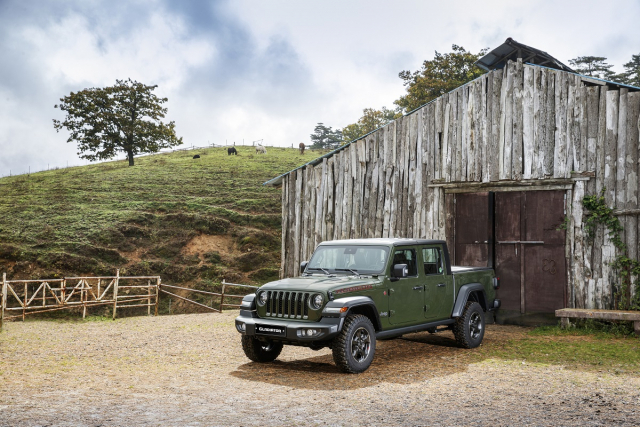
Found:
<box><xmin>331</xmin><ymin>314</ymin><xmax>376</xmax><ymax>374</ymax></box>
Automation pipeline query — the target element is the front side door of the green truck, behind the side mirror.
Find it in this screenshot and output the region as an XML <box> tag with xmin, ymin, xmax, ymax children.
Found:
<box><xmin>389</xmin><ymin>248</ymin><xmax>424</xmax><ymax>325</ymax></box>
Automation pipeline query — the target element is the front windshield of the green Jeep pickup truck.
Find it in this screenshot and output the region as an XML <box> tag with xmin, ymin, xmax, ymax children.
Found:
<box><xmin>307</xmin><ymin>245</ymin><xmax>389</xmax><ymax>274</ymax></box>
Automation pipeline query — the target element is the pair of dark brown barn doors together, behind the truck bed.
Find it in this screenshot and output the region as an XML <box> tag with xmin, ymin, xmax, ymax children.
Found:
<box><xmin>450</xmin><ymin>191</ymin><xmax>566</xmax><ymax>320</ymax></box>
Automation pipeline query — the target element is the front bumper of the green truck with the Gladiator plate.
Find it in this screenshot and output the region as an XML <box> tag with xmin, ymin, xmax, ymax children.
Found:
<box><xmin>236</xmin><ymin>310</ymin><xmax>344</xmax><ymax>345</ymax></box>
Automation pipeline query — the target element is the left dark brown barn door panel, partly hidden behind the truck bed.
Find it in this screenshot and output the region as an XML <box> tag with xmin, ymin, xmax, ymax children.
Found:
<box><xmin>450</xmin><ymin>193</ymin><xmax>493</xmax><ymax>267</ymax></box>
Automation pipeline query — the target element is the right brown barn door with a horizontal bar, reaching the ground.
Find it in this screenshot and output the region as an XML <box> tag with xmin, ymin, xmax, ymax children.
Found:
<box><xmin>495</xmin><ymin>191</ymin><xmax>566</xmax><ymax>313</ymax></box>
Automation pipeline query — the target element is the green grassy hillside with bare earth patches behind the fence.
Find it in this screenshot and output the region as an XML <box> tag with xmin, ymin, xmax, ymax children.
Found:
<box><xmin>0</xmin><ymin>147</ymin><xmax>318</xmax><ymax>289</ymax></box>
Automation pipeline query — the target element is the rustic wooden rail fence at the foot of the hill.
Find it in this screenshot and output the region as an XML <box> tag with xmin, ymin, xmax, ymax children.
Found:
<box><xmin>0</xmin><ymin>270</ymin><xmax>257</xmax><ymax>330</ymax></box>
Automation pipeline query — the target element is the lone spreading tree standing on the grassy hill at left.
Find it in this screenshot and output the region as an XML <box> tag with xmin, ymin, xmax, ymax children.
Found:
<box><xmin>53</xmin><ymin>79</ymin><xmax>182</xmax><ymax>166</ymax></box>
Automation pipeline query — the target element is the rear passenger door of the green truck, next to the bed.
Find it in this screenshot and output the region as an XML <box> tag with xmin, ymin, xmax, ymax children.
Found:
<box><xmin>420</xmin><ymin>246</ymin><xmax>453</xmax><ymax>320</ymax></box>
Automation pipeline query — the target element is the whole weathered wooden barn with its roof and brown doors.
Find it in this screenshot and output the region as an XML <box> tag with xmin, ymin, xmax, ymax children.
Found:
<box><xmin>266</xmin><ymin>39</ymin><xmax>640</xmax><ymax>320</ymax></box>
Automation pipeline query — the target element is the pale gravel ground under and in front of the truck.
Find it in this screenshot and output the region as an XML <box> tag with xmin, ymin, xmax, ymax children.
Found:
<box><xmin>0</xmin><ymin>312</ymin><xmax>640</xmax><ymax>426</ymax></box>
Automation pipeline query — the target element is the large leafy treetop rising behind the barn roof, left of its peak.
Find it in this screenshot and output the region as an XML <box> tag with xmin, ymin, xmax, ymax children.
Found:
<box><xmin>395</xmin><ymin>44</ymin><xmax>488</xmax><ymax>112</ymax></box>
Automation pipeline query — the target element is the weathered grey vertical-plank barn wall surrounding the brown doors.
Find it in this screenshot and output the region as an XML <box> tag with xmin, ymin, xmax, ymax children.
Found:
<box><xmin>282</xmin><ymin>61</ymin><xmax>640</xmax><ymax>308</ymax></box>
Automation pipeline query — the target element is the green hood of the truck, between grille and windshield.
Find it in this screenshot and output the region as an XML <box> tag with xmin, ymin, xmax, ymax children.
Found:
<box><xmin>260</xmin><ymin>275</ymin><xmax>383</xmax><ymax>292</ymax></box>
